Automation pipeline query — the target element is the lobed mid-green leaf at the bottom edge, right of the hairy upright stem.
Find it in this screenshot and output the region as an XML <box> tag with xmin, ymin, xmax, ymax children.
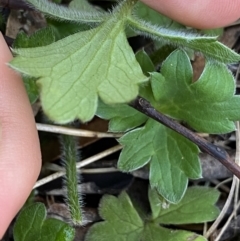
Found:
<box><xmin>86</xmin><ymin>187</ymin><xmax>219</xmax><ymax>241</ymax></box>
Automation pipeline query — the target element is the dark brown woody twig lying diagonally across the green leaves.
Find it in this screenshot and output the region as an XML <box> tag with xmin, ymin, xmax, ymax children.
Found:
<box><xmin>130</xmin><ymin>97</ymin><xmax>240</xmax><ymax>178</ymax></box>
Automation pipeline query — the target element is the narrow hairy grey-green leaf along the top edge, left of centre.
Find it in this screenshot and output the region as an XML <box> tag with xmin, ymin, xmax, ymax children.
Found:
<box><xmin>26</xmin><ymin>0</ymin><xmax>109</xmax><ymax>23</ymax></box>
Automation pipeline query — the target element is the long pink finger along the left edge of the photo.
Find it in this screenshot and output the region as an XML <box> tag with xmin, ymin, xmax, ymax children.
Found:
<box><xmin>0</xmin><ymin>33</ymin><xmax>41</xmax><ymax>238</ymax></box>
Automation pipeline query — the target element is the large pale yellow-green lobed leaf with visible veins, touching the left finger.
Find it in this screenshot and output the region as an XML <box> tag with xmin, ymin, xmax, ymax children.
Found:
<box><xmin>11</xmin><ymin>15</ymin><xmax>147</xmax><ymax>123</ymax></box>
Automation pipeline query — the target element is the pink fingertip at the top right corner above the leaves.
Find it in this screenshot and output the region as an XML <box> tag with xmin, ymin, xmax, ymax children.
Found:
<box><xmin>142</xmin><ymin>0</ymin><xmax>240</xmax><ymax>29</ymax></box>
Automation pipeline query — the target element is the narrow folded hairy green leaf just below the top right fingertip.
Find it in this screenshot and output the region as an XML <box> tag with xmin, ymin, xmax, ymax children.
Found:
<box><xmin>128</xmin><ymin>16</ymin><xmax>240</xmax><ymax>63</ymax></box>
